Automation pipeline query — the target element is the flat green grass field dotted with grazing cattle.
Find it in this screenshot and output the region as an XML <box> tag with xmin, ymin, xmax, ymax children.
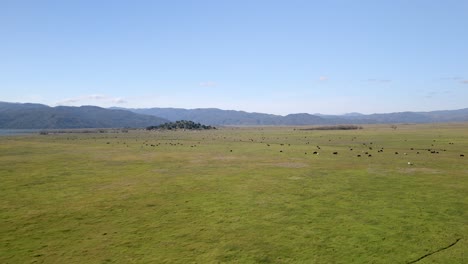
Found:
<box><xmin>0</xmin><ymin>124</ymin><xmax>468</xmax><ymax>263</ymax></box>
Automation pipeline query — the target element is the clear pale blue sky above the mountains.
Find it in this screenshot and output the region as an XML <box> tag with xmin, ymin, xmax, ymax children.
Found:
<box><xmin>0</xmin><ymin>0</ymin><xmax>468</xmax><ymax>114</ymax></box>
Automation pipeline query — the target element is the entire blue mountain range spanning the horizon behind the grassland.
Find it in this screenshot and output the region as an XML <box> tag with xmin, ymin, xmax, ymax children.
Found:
<box><xmin>0</xmin><ymin>102</ymin><xmax>468</xmax><ymax>129</ymax></box>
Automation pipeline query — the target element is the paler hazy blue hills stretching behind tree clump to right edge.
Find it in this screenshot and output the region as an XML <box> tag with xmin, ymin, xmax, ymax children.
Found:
<box><xmin>121</xmin><ymin>108</ymin><xmax>468</xmax><ymax>126</ymax></box>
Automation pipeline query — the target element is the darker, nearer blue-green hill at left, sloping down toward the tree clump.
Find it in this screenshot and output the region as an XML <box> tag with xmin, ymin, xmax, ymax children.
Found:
<box><xmin>0</xmin><ymin>102</ymin><xmax>169</xmax><ymax>129</ymax></box>
